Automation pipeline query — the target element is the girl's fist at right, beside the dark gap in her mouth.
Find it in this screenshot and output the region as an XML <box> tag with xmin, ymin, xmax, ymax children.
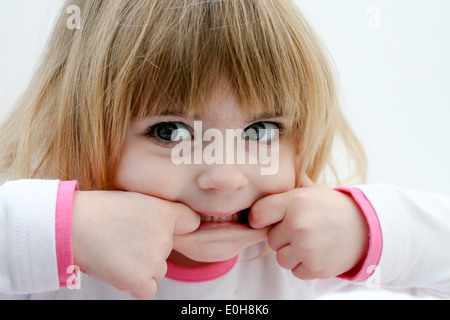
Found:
<box><xmin>249</xmin><ymin>176</ymin><xmax>369</xmax><ymax>280</ymax></box>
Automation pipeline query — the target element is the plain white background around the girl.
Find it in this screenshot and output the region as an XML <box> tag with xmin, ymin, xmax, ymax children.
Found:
<box><xmin>0</xmin><ymin>0</ymin><xmax>450</xmax><ymax>299</ymax></box>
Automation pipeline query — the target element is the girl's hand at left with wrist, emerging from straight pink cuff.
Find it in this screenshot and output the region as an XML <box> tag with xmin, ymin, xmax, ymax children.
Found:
<box><xmin>73</xmin><ymin>191</ymin><xmax>200</xmax><ymax>299</ymax></box>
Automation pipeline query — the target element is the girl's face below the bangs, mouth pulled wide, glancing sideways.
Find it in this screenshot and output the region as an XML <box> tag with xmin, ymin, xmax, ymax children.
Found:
<box><xmin>115</xmin><ymin>80</ymin><xmax>296</xmax><ymax>265</ymax></box>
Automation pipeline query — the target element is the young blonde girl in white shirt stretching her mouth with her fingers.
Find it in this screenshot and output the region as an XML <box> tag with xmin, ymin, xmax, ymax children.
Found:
<box><xmin>0</xmin><ymin>0</ymin><xmax>450</xmax><ymax>299</ymax></box>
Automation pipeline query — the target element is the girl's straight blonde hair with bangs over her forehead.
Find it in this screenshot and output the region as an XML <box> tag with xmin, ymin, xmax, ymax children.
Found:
<box><xmin>0</xmin><ymin>0</ymin><xmax>366</xmax><ymax>190</ymax></box>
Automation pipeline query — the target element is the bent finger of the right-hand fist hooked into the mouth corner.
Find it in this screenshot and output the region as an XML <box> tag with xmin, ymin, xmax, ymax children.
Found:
<box><xmin>248</xmin><ymin>193</ymin><xmax>287</xmax><ymax>229</ymax></box>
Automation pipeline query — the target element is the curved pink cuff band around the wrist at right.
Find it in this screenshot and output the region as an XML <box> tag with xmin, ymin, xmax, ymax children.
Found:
<box><xmin>335</xmin><ymin>188</ymin><xmax>383</xmax><ymax>281</ymax></box>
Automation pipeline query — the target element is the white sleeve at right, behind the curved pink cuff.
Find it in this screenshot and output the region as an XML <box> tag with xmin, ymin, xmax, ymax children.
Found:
<box><xmin>359</xmin><ymin>185</ymin><xmax>450</xmax><ymax>298</ymax></box>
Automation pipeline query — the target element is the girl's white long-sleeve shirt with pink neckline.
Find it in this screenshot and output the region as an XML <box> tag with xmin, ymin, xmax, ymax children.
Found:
<box><xmin>0</xmin><ymin>180</ymin><xmax>450</xmax><ymax>299</ymax></box>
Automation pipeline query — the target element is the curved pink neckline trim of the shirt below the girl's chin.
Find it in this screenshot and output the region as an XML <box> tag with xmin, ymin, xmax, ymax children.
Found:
<box><xmin>166</xmin><ymin>256</ymin><xmax>238</xmax><ymax>282</ymax></box>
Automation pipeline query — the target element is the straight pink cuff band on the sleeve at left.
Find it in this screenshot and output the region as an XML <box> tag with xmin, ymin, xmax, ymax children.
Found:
<box><xmin>55</xmin><ymin>181</ymin><xmax>78</xmax><ymax>287</ymax></box>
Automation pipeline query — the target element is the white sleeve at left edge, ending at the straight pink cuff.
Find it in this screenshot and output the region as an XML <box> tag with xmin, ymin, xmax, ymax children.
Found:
<box><xmin>0</xmin><ymin>180</ymin><xmax>59</xmax><ymax>294</ymax></box>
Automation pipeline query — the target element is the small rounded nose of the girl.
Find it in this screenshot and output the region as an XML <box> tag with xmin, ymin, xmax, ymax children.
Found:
<box><xmin>197</xmin><ymin>164</ymin><xmax>248</xmax><ymax>193</ymax></box>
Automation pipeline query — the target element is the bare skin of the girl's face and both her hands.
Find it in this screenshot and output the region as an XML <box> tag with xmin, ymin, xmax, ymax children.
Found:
<box><xmin>73</xmin><ymin>81</ymin><xmax>368</xmax><ymax>299</ymax></box>
